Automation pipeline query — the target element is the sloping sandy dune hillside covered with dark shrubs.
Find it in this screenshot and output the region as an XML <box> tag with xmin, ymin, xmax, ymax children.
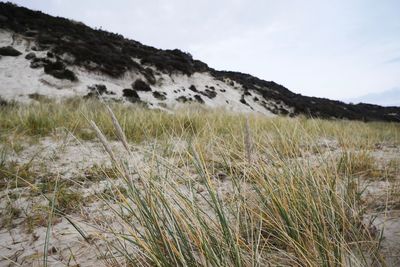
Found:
<box><xmin>0</xmin><ymin>3</ymin><xmax>400</xmax><ymax>121</ymax></box>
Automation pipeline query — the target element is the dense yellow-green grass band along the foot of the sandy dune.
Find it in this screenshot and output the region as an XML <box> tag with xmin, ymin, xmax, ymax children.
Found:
<box><xmin>0</xmin><ymin>98</ymin><xmax>400</xmax><ymax>147</ymax></box>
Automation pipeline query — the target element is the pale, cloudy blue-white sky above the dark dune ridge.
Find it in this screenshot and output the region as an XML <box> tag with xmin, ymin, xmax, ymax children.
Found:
<box><xmin>7</xmin><ymin>0</ymin><xmax>400</xmax><ymax>103</ymax></box>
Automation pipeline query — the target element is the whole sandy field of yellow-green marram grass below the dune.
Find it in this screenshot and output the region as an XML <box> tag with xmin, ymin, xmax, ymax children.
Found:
<box><xmin>0</xmin><ymin>98</ymin><xmax>400</xmax><ymax>266</ymax></box>
